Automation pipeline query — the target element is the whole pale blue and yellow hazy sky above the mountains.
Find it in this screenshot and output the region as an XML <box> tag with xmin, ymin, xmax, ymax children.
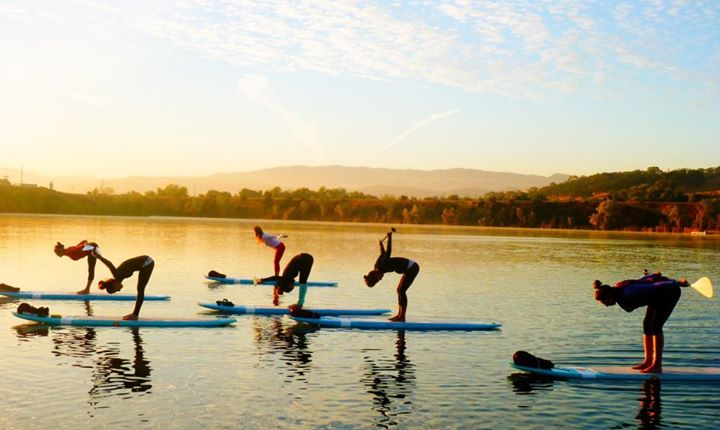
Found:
<box><xmin>0</xmin><ymin>0</ymin><xmax>720</xmax><ymax>178</ymax></box>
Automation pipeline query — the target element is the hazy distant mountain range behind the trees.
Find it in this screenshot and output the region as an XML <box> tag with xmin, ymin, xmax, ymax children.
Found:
<box><xmin>0</xmin><ymin>166</ymin><xmax>569</xmax><ymax>198</ymax></box>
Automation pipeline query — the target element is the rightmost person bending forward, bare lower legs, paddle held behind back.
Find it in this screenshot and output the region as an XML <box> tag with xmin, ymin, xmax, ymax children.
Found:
<box><xmin>593</xmin><ymin>273</ymin><xmax>688</xmax><ymax>373</ymax></box>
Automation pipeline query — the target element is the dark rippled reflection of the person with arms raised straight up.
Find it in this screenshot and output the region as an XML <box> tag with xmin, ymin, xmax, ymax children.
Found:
<box><xmin>360</xmin><ymin>330</ymin><xmax>415</xmax><ymax>428</ymax></box>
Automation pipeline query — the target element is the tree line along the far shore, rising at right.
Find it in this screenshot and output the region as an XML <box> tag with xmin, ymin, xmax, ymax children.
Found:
<box><xmin>0</xmin><ymin>167</ymin><xmax>720</xmax><ymax>234</ymax></box>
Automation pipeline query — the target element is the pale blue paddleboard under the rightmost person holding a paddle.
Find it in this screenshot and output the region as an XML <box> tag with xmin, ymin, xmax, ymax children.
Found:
<box><xmin>510</xmin><ymin>363</ymin><xmax>720</xmax><ymax>381</ymax></box>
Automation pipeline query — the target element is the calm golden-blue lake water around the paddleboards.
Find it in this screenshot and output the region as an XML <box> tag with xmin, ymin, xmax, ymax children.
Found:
<box><xmin>0</xmin><ymin>215</ymin><xmax>720</xmax><ymax>429</ymax></box>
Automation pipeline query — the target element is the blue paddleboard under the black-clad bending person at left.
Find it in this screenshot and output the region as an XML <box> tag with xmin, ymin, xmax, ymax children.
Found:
<box><xmin>13</xmin><ymin>312</ymin><xmax>237</xmax><ymax>327</ymax></box>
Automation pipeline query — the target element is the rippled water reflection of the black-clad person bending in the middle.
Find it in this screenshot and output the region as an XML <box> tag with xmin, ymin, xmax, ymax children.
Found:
<box><xmin>253</xmin><ymin>317</ymin><xmax>319</xmax><ymax>382</ymax></box>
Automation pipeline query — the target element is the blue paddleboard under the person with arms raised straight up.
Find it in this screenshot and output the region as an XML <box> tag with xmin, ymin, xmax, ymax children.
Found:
<box><xmin>290</xmin><ymin>316</ymin><xmax>502</xmax><ymax>331</ymax></box>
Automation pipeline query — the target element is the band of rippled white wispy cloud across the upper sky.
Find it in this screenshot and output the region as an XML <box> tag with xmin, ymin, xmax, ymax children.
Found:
<box><xmin>5</xmin><ymin>0</ymin><xmax>720</xmax><ymax>97</ymax></box>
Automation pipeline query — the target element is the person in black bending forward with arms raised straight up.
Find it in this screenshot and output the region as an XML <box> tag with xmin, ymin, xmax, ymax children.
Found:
<box><xmin>364</xmin><ymin>231</ymin><xmax>420</xmax><ymax>322</ymax></box>
